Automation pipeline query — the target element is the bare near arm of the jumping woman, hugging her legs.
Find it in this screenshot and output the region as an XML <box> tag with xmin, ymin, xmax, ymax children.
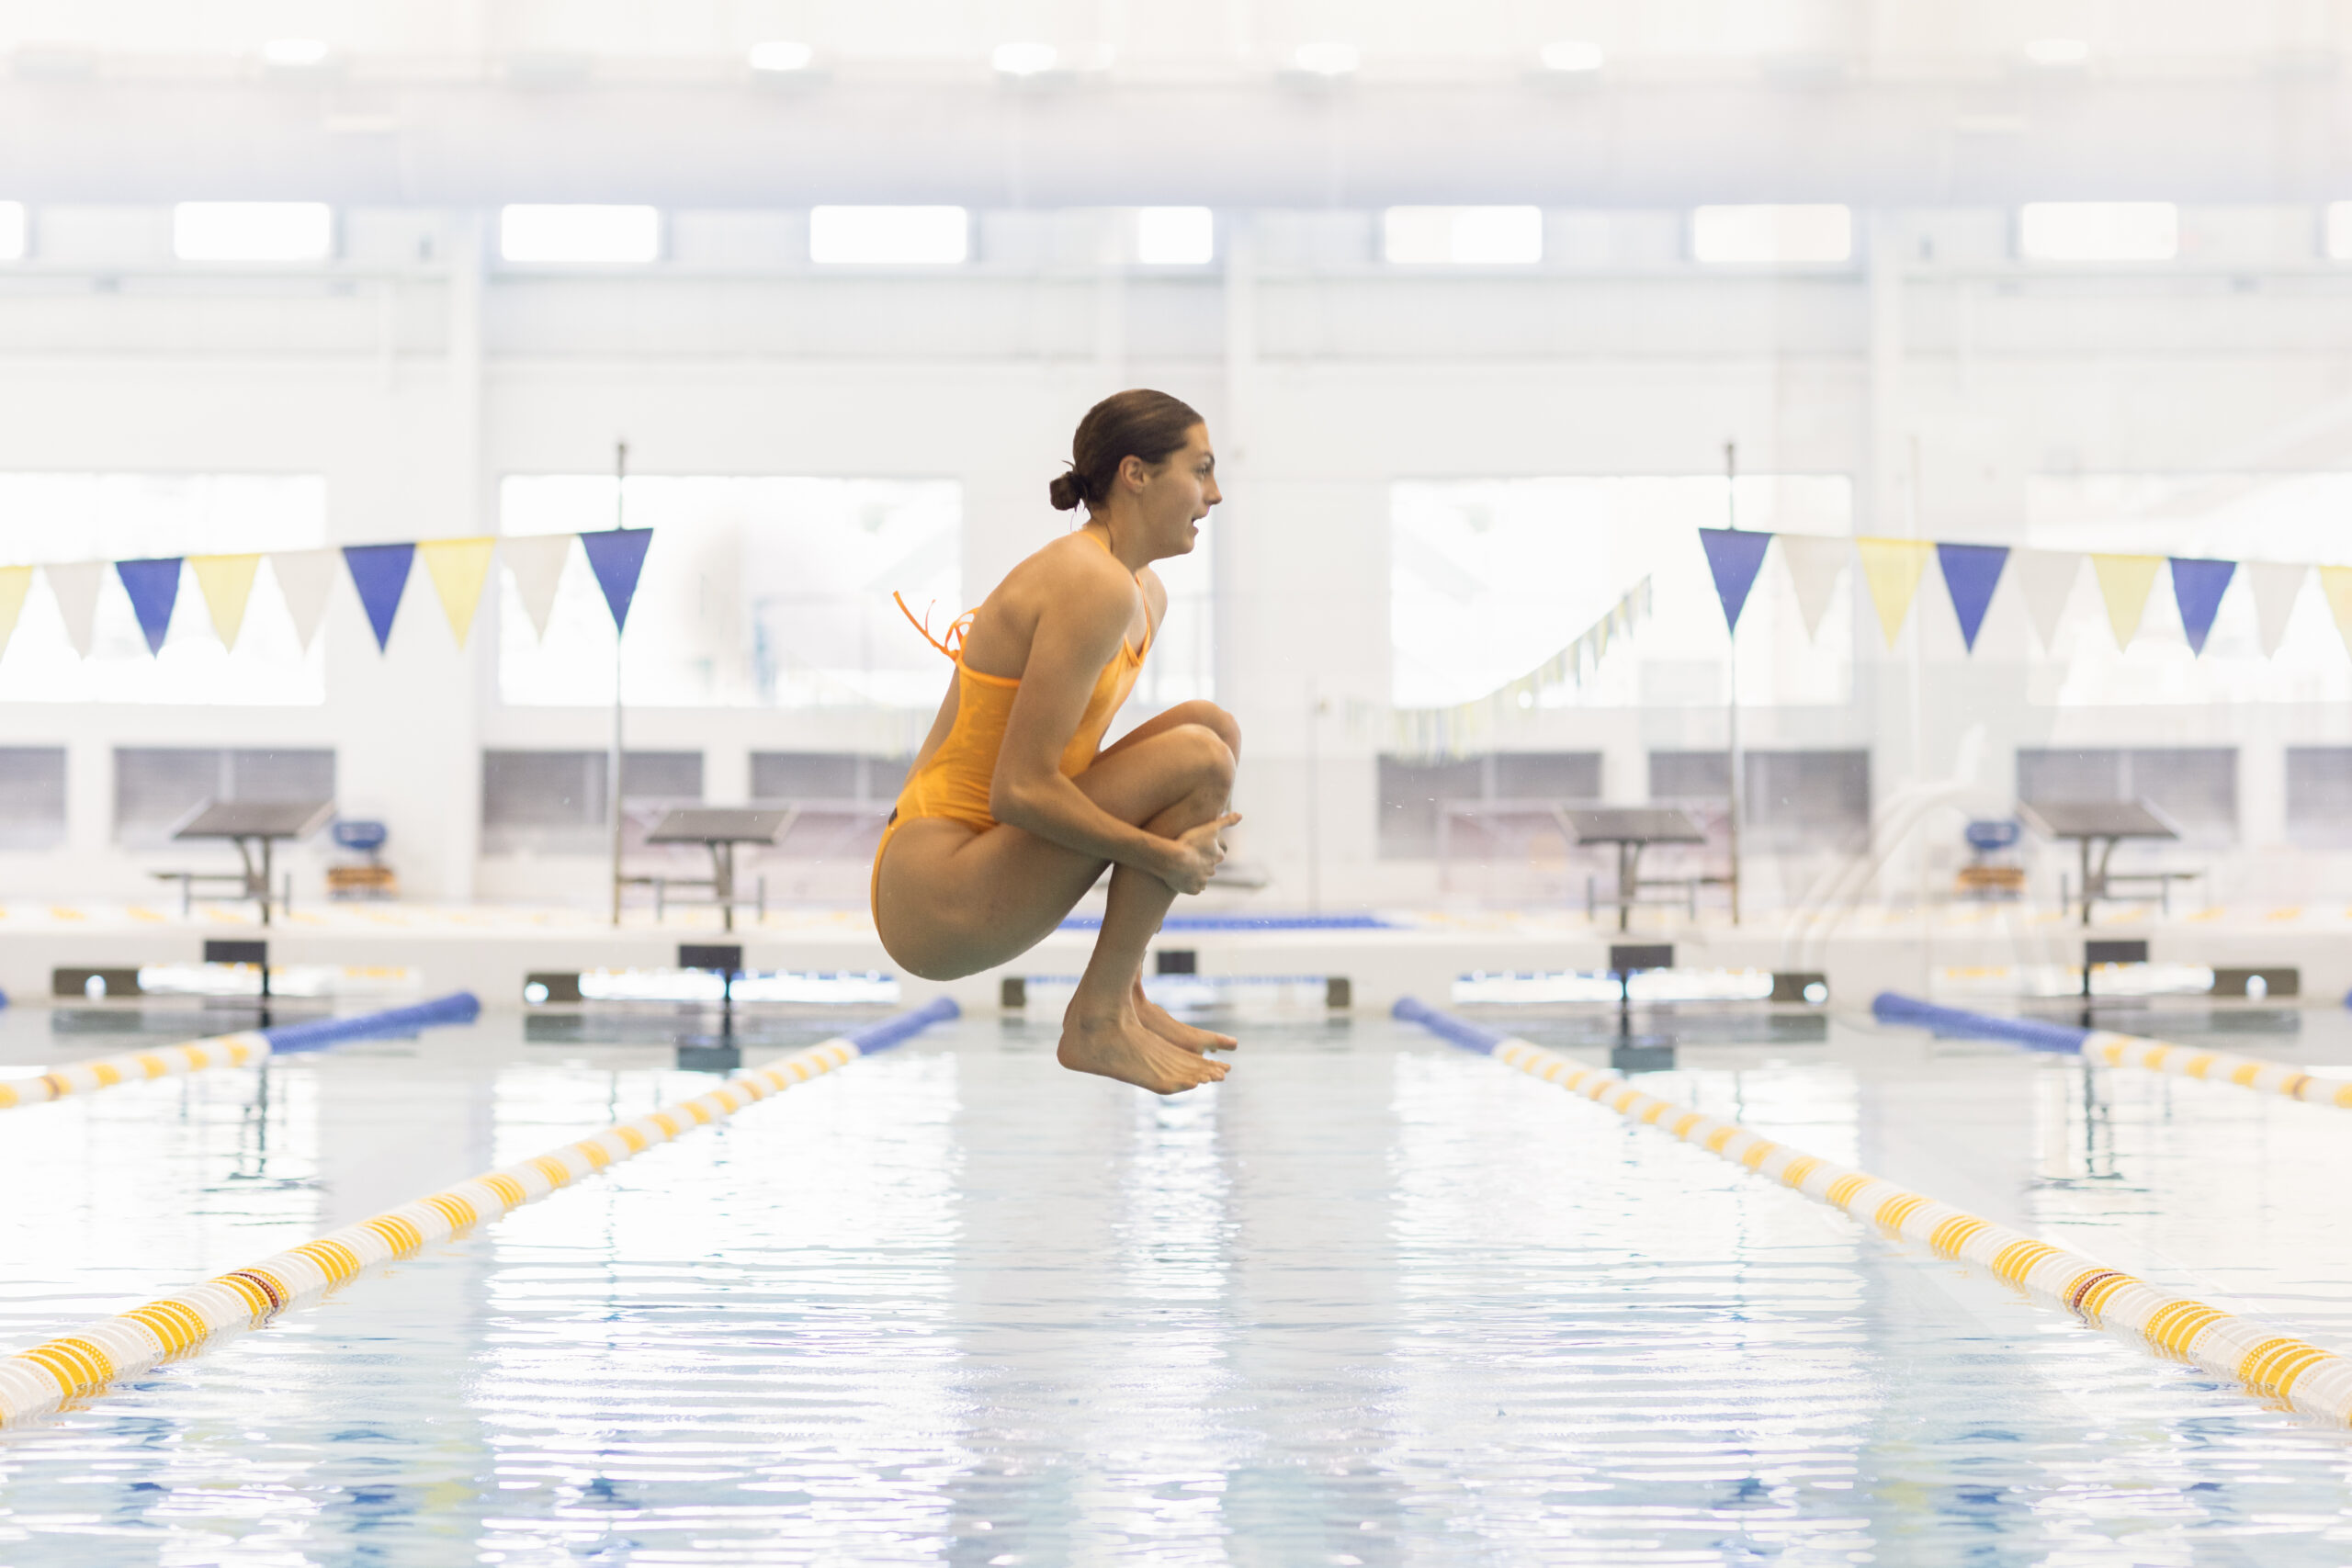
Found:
<box><xmin>988</xmin><ymin>562</ymin><xmax>1200</xmax><ymax>891</ymax></box>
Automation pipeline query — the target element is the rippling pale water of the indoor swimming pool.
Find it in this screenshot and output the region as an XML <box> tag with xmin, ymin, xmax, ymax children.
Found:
<box><xmin>0</xmin><ymin>1010</ymin><xmax>2352</xmax><ymax>1565</ymax></box>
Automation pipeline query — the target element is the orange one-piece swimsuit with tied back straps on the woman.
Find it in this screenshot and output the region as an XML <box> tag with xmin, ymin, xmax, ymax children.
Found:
<box><xmin>865</xmin><ymin>534</ymin><xmax>1158</xmax><ymax>919</ymax></box>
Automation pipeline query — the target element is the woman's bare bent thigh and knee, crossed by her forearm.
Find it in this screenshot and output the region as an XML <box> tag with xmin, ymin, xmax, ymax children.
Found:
<box><xmin>875</xmin><ymin>724</ymin><xmax>1232</xmax><ymax>980</ymax></box>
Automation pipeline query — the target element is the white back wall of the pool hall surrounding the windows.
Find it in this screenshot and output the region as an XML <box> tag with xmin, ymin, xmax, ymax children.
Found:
<box><xmin>0</xmin><ymin>209</ymin><xmax>2352</xmax><ymax>905</ymax></box>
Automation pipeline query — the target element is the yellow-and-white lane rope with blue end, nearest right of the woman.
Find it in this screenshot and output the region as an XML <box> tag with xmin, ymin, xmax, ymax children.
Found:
<box><xmin>1395</xmin><ymin>997</ymin><xmax>2352</xmax><ymax>1422</ymax></box>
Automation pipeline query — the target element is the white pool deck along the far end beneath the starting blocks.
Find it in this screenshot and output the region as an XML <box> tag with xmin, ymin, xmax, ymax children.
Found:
<box><xmin>0</xmin><ymin>900</ymin><xmax>2352</xmax><ymax>1010</ymax></box>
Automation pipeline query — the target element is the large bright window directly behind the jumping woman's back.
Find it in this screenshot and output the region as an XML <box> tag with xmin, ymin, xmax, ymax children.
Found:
<box><xmin>499</xmin><ymin>475</ymin><xmax>959</xmax><ymax>712</ymax></box>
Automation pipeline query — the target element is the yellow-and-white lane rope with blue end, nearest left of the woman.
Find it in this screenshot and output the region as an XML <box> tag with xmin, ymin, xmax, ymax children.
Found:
<box><xmin>0</xmin><ymin>997</ymin><xmax>957</xmax><ymax>1427</ymax></box>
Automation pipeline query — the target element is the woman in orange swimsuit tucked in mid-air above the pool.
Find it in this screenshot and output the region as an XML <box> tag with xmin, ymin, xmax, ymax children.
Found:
<box><xmin>873</xmin><ymin>390</ymin><xmax>1242</xmax><ymax>1093</ymax></box>
